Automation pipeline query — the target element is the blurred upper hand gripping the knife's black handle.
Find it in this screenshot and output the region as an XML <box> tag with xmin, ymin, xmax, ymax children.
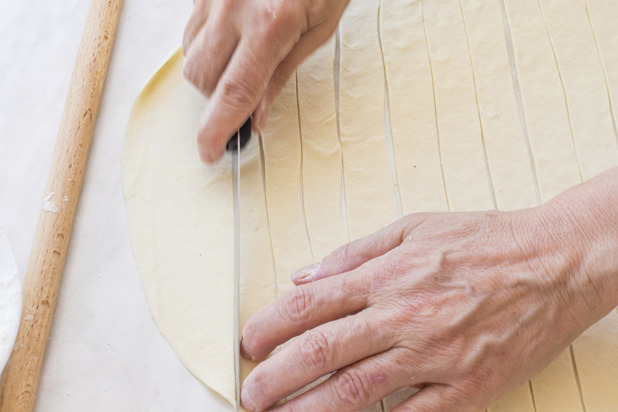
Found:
<box><xmin>182</xmin><ymin>0</ymin><xmax>349</xmax><ymax>163</ymax></box>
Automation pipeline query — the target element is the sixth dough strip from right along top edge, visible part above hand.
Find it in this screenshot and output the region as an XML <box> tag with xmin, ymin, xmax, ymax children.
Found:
<box><xmin>380</xmin><ymin>0</ymin><xmax>448</xmax><ymax>214</ymax></box>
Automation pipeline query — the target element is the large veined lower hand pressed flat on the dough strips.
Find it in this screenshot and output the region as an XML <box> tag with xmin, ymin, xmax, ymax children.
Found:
<box><xmin>236</xmin><ymin>169</ymin><xmax>618</xmax><ymax>412</ymax></box>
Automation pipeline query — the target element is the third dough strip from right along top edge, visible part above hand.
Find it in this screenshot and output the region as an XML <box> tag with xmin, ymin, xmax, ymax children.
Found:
<box><xmin>504</xmin><ymin>0</ymin><xmax>581</xmax><ymax>202</ymax></box>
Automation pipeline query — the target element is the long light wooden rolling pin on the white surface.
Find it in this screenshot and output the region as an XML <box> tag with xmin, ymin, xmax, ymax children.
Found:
<box><xmin>0</xmin><ymin>0</ymin><xmax>122</xmax><ymax>412</ymax></box>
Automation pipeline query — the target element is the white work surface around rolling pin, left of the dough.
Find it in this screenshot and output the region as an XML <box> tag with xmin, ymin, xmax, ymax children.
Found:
<box><xmin>0</xmin><ymin>0</ymin><xmax>231</xmax><ymax>412</ymax></box>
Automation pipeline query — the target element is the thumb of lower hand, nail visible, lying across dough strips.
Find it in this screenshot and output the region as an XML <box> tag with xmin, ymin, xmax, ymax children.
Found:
<box><xmin>292</xmin><ymin>216</ymin><xmax>416</xmax><ymax>285</ymax></box>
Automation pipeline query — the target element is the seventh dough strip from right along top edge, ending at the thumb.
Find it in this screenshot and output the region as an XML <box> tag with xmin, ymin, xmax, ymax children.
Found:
<box><xmin>339</xmin><ymin>0</ymin><xmax>397</xmax><ymax>240</ymax></box>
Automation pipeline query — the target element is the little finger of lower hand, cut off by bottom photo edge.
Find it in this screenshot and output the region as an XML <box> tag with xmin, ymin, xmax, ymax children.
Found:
<box><xmin>393</xmin><ymin>384</ymin><xmax>466</xmax><ymax>412</ymax></box>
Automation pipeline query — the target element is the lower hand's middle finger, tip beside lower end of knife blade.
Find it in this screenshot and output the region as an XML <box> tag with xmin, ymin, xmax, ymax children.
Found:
<box><xmin>243</xmin><ymin>311</ymin><xmax>394</xmax><ymax>409</ymax></box>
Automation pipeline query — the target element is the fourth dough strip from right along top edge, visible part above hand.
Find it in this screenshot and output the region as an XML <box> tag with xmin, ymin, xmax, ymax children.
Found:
<box><xmin>459</xmin><ymin>0</ymin><xmax>539</xmax><ymax>210</ymax></box>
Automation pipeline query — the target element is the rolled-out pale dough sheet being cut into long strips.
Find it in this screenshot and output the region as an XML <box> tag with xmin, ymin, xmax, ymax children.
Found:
<box><xmin>123</xmin><ymin>0</ymin><xmax>618</xmax><ymax>412</ymax></box>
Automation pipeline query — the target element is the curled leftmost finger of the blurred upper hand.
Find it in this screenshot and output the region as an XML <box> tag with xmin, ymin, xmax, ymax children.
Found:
<box><xmin>183</xmin><ymin>16</ymin><xmax>240</xmax><ymax>96</ymax></box>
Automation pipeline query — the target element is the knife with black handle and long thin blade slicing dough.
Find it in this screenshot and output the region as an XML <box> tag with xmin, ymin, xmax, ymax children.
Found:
<box><xmin>226</xmin><ymin>117</ymin><xmax>251</xmax><ymax>412</ymax></box>
